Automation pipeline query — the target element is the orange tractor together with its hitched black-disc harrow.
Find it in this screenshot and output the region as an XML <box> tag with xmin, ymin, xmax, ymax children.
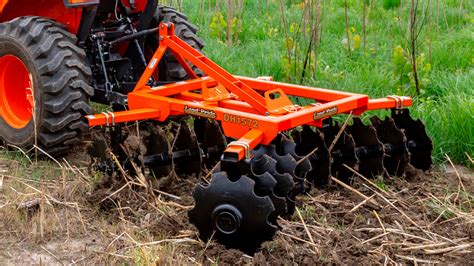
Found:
<box><xmin>0</xmin><ymin>0</ymin><xmax>433</xmax><ymax>254</ymax></box>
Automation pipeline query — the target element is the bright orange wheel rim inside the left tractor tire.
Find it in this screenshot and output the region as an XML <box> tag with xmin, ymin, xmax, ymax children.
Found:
<box><xmin>0</xmin><ymin>55</ymin><xmax>34</xmax><ymax>129</ymax></box>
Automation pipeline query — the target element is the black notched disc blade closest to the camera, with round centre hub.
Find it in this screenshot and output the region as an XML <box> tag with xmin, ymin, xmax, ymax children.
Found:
<box><xmin>188</xmin><ymin>172</ymin><xmax>277</xmax><ymax>254</ymax></box>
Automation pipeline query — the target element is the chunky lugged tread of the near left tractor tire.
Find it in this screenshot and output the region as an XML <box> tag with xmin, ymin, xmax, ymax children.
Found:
<box><xmin>0</xmin><ymin>16</ymin><xmax>94</xmax><ymax>155</ymax></box>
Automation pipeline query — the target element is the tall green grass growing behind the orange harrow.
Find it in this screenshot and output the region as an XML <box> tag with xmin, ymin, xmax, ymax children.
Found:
<box><xmin>172</xmin><ymin>0</ymin><xmax>474</xmax><ymax>165</ymax></box>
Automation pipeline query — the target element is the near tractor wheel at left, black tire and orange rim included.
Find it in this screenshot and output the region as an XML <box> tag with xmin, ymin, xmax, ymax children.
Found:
<box><xmin>0</xmin><ymin>17</ymin><xmax>93</xmax><ymax>155</ymax></box>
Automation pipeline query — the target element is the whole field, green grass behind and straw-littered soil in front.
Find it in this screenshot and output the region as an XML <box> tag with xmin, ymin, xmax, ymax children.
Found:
<box><xmin>0</xmin><ymin>0</ymin><xmax>474</xmax><ymax>265</ymax></box>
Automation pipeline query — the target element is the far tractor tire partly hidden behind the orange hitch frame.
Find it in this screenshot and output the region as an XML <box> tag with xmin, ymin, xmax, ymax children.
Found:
<box><xmin>147</xmin><ymin>6</ymin><xmax>204</xmax><ymax>81</ymax></box>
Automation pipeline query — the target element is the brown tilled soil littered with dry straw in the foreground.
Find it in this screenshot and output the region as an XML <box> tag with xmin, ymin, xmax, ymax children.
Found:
<box><xmin>0</xmin><ymin>152</ymin><xmax>474</xmax><ymax>265</ymax></box>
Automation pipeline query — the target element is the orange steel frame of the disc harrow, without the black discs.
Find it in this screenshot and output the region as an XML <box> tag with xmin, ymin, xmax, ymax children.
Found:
<box><xmin>86</xmin><ymin>23</ymin><xmax>412</xmax><ymax>162</ymax></box>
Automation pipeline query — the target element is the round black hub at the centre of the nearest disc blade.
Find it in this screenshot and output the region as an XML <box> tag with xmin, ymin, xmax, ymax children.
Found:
<box><xmin>212</xmin><ymin>204</ymin><xmax>242</xmax><ymax>235</ymax></box>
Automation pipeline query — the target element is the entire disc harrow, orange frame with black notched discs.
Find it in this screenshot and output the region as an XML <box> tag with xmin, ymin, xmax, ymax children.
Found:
<box><xmin>87</xmin><ymin>23</ymin><xmax>433</xmax><ymax>254</ymax></box>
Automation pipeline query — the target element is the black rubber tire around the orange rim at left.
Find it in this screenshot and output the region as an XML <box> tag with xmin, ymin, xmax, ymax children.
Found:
<box><xmin>0</xmin><ymin>17</ymin><xmax>94</xmax><ymax>155</ymax></box>
